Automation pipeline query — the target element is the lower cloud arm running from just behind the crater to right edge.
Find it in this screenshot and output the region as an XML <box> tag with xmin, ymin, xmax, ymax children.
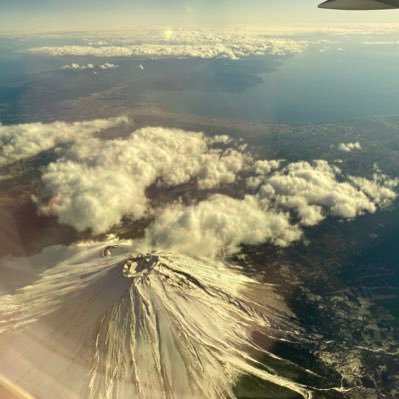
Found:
<box><xmin>144</xmin><ymin>161</ymin><xmax>398</xmax><ymax>257</ymax></box>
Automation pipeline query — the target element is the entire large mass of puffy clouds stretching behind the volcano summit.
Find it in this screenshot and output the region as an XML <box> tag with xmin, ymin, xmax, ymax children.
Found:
<box><xmin>0</xmin><ymin>117</ymin><xmax>398</xmax><ymax>257</ymax></box>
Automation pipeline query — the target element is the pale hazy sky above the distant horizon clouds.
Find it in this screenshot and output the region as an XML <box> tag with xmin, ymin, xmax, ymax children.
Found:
<box><xmin>0</xmin><ymin>0</ymin><xmax>399</xmax><ymax>32</ymax></box>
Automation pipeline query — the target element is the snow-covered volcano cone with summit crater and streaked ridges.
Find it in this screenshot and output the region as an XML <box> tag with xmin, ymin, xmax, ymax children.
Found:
<box><xmin>0</xmin><ymin>240</ymin><xmax>311</xmax><ymax>399</ymax></box>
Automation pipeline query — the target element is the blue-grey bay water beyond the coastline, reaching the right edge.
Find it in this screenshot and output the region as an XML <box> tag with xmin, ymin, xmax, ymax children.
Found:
<box><xmin>147</xmin><ymin>45</ymin><xmax>399</xmax><ymax>123</ymax></box>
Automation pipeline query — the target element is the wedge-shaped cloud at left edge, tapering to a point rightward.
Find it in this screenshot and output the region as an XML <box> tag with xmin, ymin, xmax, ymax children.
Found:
<box><xmin>0</xmin><ymin>116</ymin><xmax>127</xmax><ymax>166</ymax></box>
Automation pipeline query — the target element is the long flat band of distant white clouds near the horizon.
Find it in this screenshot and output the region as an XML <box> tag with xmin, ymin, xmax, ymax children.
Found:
<box><xmin>26</xmin><ymin>29</ymin><xmax>310</xmax><ymax>59</ymax></box>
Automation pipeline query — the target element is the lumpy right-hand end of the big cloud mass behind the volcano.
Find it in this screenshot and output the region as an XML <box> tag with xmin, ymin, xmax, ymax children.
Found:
<box><xmin>252</xmin><ymin>161</ymin><xmax>397</xmax><ymax>226</ymax></box>
